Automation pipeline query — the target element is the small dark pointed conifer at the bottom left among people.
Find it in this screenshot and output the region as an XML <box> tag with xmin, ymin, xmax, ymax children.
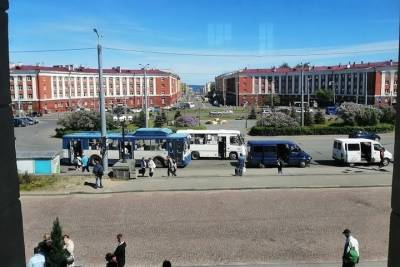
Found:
<box><xmin>49</xmin><ymin>217</ymin><xmax>67</xmax><ymax>267</ymax></box>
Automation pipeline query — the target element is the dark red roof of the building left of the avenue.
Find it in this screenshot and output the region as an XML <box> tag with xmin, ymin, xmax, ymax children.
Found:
<box><xmin>10</xmin><ymin>65</ymin><xmax>179</xmax><ymax>78</ymax></box>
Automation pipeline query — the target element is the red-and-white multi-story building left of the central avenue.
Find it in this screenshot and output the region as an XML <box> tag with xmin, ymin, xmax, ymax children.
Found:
<box><xmin>10</xmin><ymin>65</ymin><xmax>181</xmax><ymax>113</ymax></box>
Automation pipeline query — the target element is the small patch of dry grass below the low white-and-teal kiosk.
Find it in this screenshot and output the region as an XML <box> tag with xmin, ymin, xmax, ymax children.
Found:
<box><xmin>18</xmin><ymin>173</ymin><xmax>58</xmax><ymax>191</ymax></box>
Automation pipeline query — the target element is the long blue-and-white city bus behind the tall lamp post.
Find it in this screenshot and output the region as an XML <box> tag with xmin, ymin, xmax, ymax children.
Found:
<box><xmin>62</xmin><ymin>128</ymin><xmax>191</xmax><ymax>167</ymax></box>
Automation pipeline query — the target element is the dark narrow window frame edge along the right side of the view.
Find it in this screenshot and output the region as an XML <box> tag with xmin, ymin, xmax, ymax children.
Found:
<box><xmin>388</xmin><ymin>32</ymin><xmax>400</xmax><ymax>267</ymax></box>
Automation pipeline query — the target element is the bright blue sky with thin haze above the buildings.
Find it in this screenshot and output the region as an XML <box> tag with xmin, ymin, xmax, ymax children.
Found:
<box><xmin>8</xmin><ymin>0</ymin><xmax>400</xmax><ymax>84</ymax></box>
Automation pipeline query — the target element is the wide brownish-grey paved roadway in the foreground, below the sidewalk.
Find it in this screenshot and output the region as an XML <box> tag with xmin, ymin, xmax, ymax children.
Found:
<box><xmin>21</xmin><ymin>188</ymin><xmax>390</xmax><ymax>267</ymax></box>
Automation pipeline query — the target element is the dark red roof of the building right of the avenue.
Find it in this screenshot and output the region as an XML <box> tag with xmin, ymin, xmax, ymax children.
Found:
<box><xmin>220</xmin><ymin>60</ymin><xmax>398</xmax><ymax>77</ymax></box>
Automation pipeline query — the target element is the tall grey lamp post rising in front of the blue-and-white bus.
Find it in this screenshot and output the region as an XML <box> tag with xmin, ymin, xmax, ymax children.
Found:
<box><xmin>93</xmin><ymin>29</ymin><xmax>108</xmax><ymax>174</ymax></box>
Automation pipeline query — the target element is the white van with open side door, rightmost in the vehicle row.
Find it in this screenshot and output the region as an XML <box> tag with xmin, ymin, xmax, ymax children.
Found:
<box><xmin>332</xmin><ymin>138</ymin><xmax>393</xmax><ymax>166</ymax></box>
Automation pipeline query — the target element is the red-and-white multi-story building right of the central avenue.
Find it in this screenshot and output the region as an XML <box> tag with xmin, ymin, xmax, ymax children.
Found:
<box><xmin>215</xmin><ymin>60</ymin><xmax>398</xmax><ymax>106</ymax></box>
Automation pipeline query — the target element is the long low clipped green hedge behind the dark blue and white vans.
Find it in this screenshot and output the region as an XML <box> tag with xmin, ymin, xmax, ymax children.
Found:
<box><xmin>249</xmin><ymin>124</ymin><xmax>394</xmax><ymax>136</ymax></box>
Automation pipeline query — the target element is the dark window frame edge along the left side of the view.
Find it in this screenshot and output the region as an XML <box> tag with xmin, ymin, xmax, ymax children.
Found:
<box><xmin>0</xmin><ymin>0</ymin><xmax>25</xmax><ymax>267</ymax></box>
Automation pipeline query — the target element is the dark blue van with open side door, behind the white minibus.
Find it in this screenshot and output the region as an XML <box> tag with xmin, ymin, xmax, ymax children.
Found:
<box><xmin>247</xmin><ymin>140</ymin><xmax>311</xmax><ymax>168</ymax></box>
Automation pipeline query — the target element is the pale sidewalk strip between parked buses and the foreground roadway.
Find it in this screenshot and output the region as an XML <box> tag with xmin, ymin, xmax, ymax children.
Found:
<box><xmin>22</xmin><ymin>167</ymin><xmax>392</xmax><ymax>195</ymax></box>
